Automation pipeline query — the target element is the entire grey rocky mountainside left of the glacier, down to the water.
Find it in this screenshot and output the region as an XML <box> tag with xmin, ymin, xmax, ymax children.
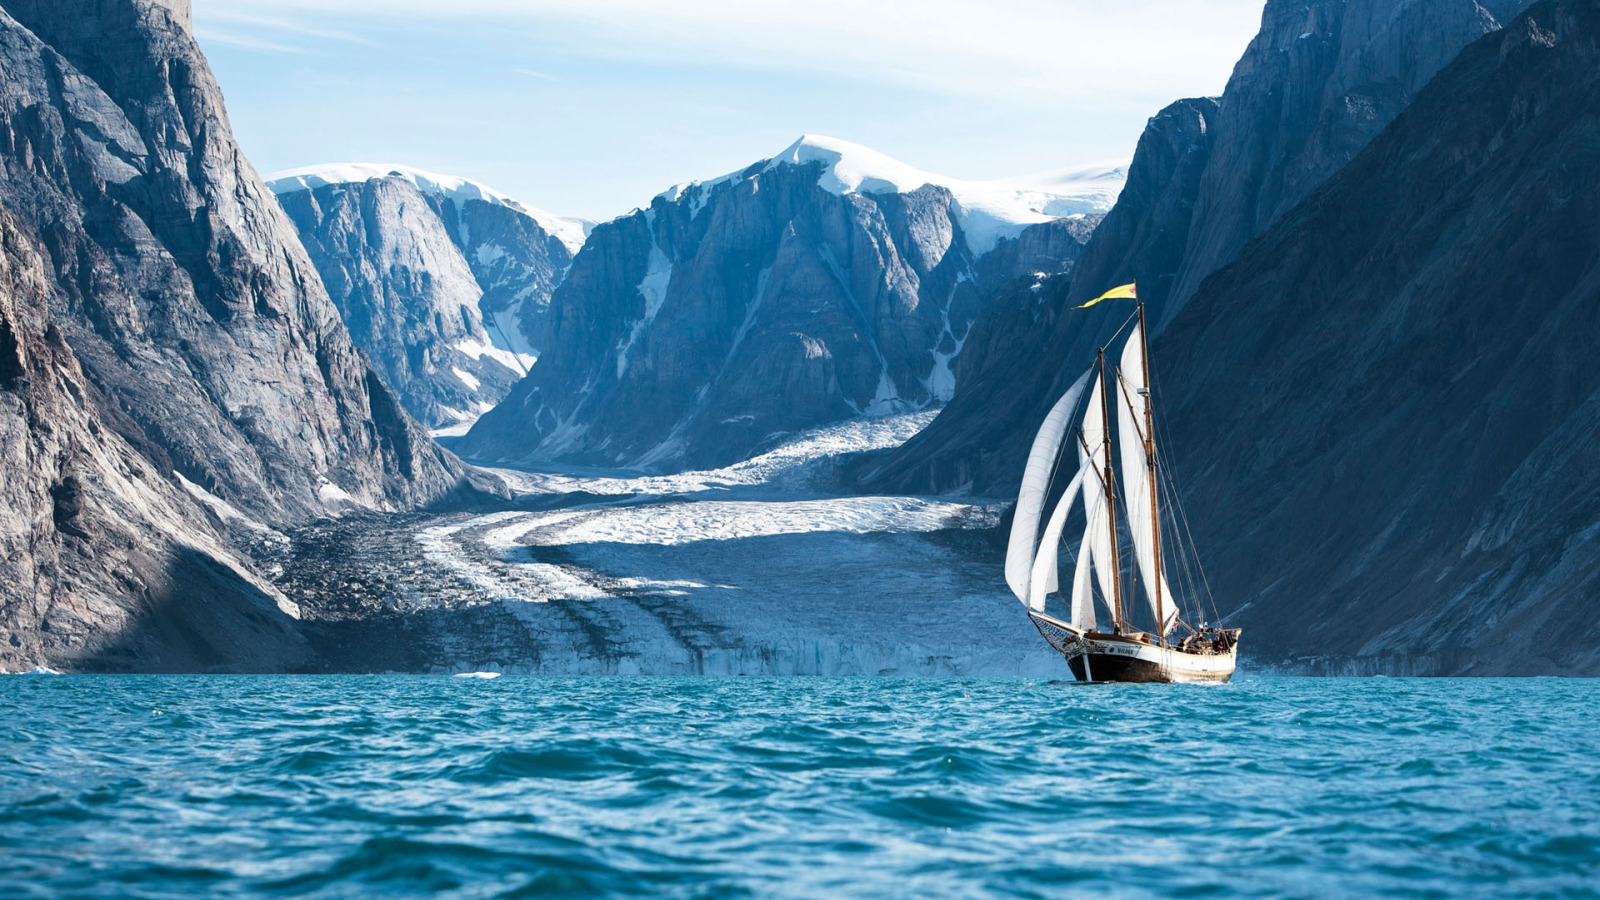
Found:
<box><xmin>0</xmin><ymin>0</ymin><xmax>486</xmax><ymax>669</ymax></box>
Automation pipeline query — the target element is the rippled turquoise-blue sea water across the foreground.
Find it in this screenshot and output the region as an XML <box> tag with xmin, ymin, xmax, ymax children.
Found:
<box><xmin>0</xmin><ymin>676</ymin><xmax>1600</xmax><ymax>898</ymax></box>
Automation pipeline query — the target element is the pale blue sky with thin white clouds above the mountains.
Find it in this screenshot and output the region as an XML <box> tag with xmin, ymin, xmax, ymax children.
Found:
<box><xmin>194</xmin><ymin>0</ymin><xmax>1261</xmax><ymax>219</ymax></box>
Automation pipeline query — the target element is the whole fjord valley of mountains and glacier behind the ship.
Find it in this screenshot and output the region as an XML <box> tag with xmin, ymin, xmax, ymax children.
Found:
<box><xmin>0</xmin><ymin>0</ymin><xmax>1600</xmax><ymax>677</ymax></box>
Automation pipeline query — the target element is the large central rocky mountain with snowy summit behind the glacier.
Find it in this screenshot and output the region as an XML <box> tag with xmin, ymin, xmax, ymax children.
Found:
<box><xmin>459</xmin><ymin>136</ymin><xmax>1122</xmax><ymax>468</ymax></box>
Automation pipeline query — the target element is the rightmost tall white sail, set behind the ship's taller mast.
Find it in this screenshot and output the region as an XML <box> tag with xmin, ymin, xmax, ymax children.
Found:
<box><xmin>1112</xmin><ymin>325</ymin><xmax>1178</xmax><ymax>634</ymax></box>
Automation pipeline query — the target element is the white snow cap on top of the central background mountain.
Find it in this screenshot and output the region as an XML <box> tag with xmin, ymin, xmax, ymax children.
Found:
<box><xmin>662</xmin><ymin>135</ymin><xmax>1128</xmax><ymax>255</ymax></box>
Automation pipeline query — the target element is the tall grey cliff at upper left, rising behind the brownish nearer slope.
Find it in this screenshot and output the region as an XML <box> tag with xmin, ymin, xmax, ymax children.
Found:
<box><xmin>0</xmin><ymin>0</ymin><xmax>462</xmax><ymax>524</ymax></box>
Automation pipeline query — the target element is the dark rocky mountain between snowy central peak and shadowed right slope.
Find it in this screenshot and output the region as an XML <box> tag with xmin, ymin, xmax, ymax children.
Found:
<box><xmin>861</xmin><ymin>0</ymin><xmax>1526</xmax><ymax>495</ymax></box>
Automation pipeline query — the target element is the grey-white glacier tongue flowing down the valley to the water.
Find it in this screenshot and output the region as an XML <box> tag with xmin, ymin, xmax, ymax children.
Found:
<box><xmin>392</xmin><ymin>413</ymin><xmax>1066</xmax><ymax>676</ymax></box>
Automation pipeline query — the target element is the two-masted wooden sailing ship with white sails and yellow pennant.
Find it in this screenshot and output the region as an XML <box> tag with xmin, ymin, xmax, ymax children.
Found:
<box><xmin>1005</xmin><ymin>294</ymin><xmax>1240</xmax><ymax>682</ymax></box>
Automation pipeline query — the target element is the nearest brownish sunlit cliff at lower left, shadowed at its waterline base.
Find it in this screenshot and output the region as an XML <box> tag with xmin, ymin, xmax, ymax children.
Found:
<box><xmin>0</xmin><ymin>199</ymin><xmax>304</xmax><ymax>671</ymax></box>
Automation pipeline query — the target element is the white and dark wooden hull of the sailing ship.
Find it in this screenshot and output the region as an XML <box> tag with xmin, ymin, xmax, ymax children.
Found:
<box><xmin>1029</xmin><ymin>613</ymin><xmax>1238</xmax><ymax>684</ymax></box>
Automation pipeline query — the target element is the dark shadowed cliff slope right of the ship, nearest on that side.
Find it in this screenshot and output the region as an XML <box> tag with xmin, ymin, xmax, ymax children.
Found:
<box><xmin>1152</xmin><ymin>0</ymin><xmax>1600</xmax><ymax>674</ymax></box>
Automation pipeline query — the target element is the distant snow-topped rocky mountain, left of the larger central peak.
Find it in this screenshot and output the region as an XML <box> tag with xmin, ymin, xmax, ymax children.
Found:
<box><xmin>267</xmin><ymin>163</ymin><xmax>589</xmax><ymax>434</ymax></box>
